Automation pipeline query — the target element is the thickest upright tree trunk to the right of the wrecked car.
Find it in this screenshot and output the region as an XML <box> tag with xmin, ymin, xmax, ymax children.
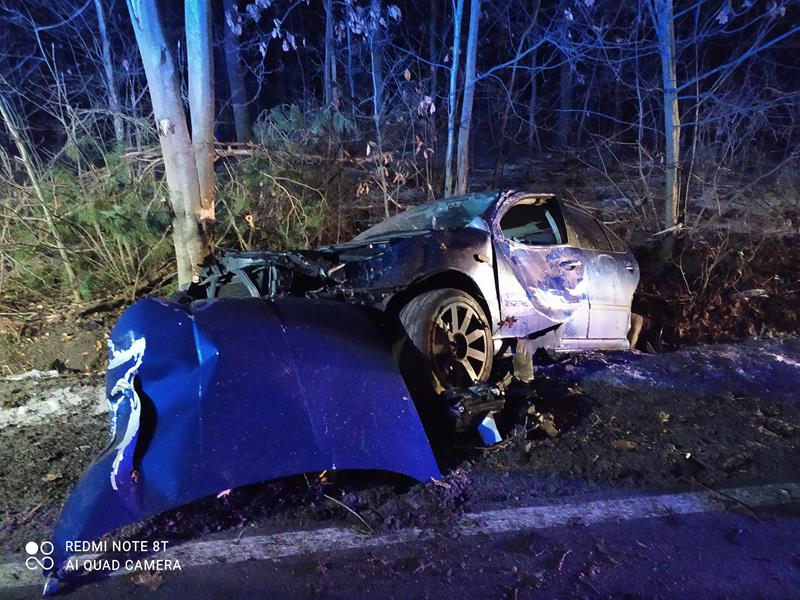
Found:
<box><xmin>654</xmin><ymin>0</ymin><xmax>681</xmax><ymax>259</ymax></box>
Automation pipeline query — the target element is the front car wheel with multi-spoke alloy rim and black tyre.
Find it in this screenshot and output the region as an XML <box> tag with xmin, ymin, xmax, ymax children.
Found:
<box><xmin>400</xmin><ymin>288</ymin><xmax>494</xmax><ymax>393</ymax></box>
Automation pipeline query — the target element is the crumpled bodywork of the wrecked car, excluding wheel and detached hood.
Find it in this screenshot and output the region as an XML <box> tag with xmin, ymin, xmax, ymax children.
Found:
<box><xmin>197</xmin><ymin>191</ymin><xmax>639</xmax><ymax>350</ymax></box>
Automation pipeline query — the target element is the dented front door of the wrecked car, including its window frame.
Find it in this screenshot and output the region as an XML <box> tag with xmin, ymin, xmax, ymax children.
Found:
<box><xmin>492</xmin><ymin>194</ymin><xmax>589</xmax><ymax>341</ymax></box>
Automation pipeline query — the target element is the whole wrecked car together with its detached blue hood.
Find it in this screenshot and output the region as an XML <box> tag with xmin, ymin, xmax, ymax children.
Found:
<box><xmin>45</xmin><ymin>192</ymin><xmax>639</xmax><ymax>592</ymax></box>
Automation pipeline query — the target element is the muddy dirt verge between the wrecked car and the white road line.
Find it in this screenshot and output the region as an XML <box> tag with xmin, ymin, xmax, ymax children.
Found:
<box><xmin>0</xmin><ymin>339</ymin><xmax>800</xmax><ymax>568</ymax></box>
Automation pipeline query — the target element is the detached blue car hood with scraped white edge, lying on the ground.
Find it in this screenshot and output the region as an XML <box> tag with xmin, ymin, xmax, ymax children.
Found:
<box><xmin>46</xmin><ymin>298</ymin><xmax>440</xmax><ymax>578</ymax></box>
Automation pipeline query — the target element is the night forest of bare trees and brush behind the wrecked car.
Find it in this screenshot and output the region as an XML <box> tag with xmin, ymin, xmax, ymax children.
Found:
<box><xmin>0</xmin><ymin>0</ymin><xmax>800</xmax><ymax>306</ymax></box>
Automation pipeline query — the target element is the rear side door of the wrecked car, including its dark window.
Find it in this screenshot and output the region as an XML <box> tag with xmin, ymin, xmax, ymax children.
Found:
<box><xmin>564</xmin><ymin>205</ymin><xmax>639</xmax><ymax>348</ymax></box>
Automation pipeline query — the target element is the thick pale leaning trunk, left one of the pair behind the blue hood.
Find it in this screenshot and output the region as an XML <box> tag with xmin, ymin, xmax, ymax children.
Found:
<box><xmin>127</xmin><ymin>0</ymin><xmax>211</xmax><ymax>288</ymax></box>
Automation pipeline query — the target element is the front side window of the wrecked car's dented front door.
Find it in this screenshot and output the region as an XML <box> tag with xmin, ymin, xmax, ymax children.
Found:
<box><xmin>500</xmin><ymin>198</ymin><xmax>566</xmax><ymax>246</ymax></box>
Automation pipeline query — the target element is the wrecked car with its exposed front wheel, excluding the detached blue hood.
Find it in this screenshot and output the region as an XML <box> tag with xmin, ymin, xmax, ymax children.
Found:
<box><xmin>190</xmin><ymin>191</ymin><xmax>639</xmax><ymax>392</ymax></box>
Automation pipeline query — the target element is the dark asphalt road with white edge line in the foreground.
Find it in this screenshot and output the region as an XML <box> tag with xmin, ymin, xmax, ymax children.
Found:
<box><xmin>0</xmin><ymin>483</ymin><xmax>800</xmax><ymax>599</ymax></box>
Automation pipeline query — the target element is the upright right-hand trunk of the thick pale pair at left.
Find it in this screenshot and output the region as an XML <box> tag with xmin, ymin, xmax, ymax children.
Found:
<box><xmin>184</xmin><ymin>0</ymin><xmax>215</xmax><ymax>253</ymax></box>
